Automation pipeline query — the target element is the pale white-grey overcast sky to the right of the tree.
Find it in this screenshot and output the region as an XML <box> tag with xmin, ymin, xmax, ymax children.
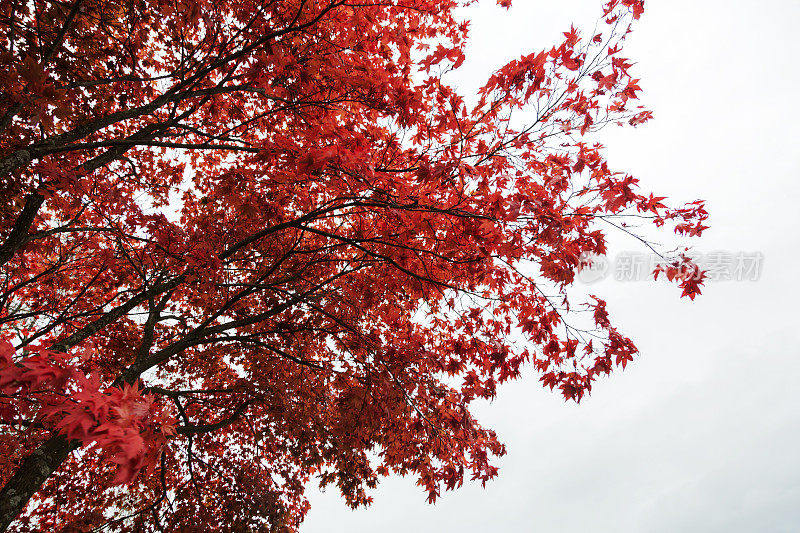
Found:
<box><xmin>301</xmin><ymin>0</ymin><xmax>800</xmax><ymax>533</ymax></box>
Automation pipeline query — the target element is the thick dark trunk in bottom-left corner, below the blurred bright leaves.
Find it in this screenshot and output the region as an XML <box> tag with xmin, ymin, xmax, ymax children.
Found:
<box><xmin>0</xmin><ymin>435</ymin><xmax>77</xmax><ymax>531</ymax></box>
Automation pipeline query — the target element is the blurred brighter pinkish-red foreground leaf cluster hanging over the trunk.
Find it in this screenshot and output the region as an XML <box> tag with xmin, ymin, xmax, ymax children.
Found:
<box><xmin>0</xmin><ymin>341</ymin><xmax>175</xmax><ymax>484</ymax></box>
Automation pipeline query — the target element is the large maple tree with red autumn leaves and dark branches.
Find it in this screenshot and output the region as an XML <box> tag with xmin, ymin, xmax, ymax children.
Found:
<box><xmin>0</xmin><ymin>0</ymin><xmax>706</xmax><ymax>531</ymax></box>
